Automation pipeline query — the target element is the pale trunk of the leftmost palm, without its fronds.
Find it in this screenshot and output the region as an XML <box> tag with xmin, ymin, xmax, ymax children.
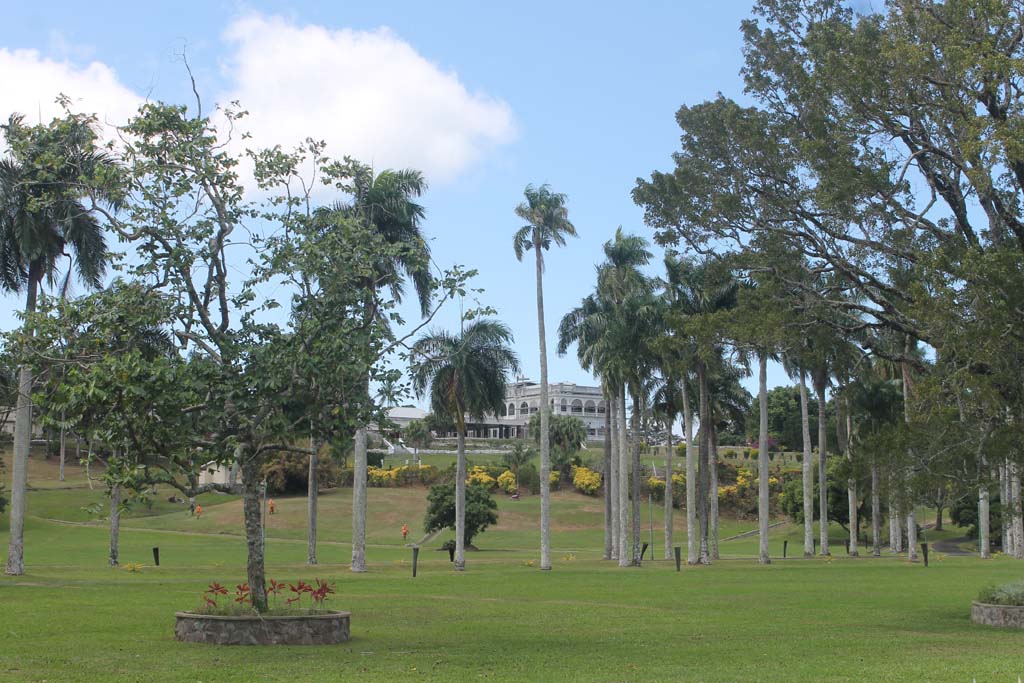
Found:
<box><xmin>5</xmin><ymin>270</ymin><xmax>40</xmax><ymax>577</ymax></box>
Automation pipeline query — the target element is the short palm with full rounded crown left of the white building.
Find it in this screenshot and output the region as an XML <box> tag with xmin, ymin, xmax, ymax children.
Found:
<box><xmin>413</xmin><ymin>318</ymin><xmax>519</xmax><ymax>570</ymax></box>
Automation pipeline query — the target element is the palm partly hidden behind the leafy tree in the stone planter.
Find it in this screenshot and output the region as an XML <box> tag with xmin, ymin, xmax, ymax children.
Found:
<box><xmin>317</xmin><ymin>163</ymin><xmax>433</xmax><ymax>571</ymax></box>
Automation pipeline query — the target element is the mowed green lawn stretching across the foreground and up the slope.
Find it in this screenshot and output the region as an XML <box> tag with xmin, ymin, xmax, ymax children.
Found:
<box><xmin>0</xmin><ymin>450</ymin><xmax>1024</xmax><ymax>683</ymax></box>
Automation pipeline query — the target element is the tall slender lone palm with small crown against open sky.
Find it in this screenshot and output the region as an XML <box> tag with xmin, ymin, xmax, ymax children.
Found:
<box><xmin>512</xmin><ymin>184</ymin><xmax>577</xmax><ymax>569</ymax></box>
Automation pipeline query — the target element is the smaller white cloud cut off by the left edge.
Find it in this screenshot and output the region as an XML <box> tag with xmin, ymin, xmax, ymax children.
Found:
<box><xmin>0</xmin><ymin>48</ymin><xmax>142</xmax><ymax>133</ymax></box>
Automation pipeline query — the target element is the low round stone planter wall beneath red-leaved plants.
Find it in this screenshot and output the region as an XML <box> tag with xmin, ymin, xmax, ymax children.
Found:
<box><xmin>174</xmin><ymin>611</ymin><xmax>351</xmax><ymax>645</ymax></box>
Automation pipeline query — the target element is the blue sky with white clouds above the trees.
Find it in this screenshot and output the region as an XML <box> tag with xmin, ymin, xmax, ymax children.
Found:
<box><xmin>0</xmin><ymin>0</ymin><xmax>788</xmax><ymax>405</ymax></box>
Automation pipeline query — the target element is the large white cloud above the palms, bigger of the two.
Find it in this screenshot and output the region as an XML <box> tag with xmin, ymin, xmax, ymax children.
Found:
<box><xmin>220</xmin><ymin>14</ymin><xmax>515</xmax><ymax>184</ymax></box>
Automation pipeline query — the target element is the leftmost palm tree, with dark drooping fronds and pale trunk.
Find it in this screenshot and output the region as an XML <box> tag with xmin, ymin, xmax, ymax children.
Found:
<box><xmin>0</xmin><ymin>115</ymin><xmax>119</xmax><ymax>575</ymax></box>
